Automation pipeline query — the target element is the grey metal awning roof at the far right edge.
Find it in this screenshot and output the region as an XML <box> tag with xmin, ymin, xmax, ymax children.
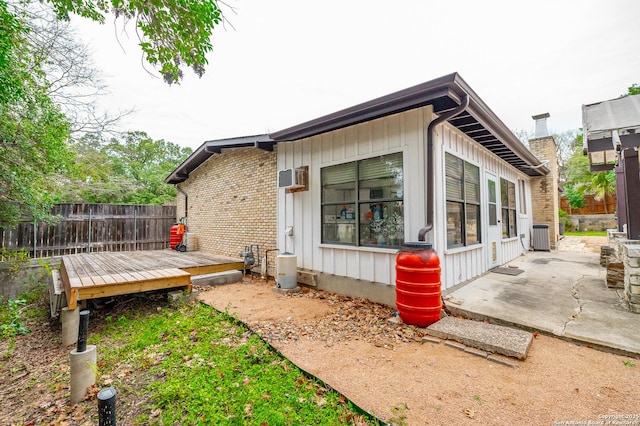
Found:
<box><xmin>582</xmin><ymin>95</ymin><xmax>640</xmax><ymax>172</ymax></box>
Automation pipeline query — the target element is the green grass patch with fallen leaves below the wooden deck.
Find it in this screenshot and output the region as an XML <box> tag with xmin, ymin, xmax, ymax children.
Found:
<box><xmin>90</xmin><ymin>304</ymin><xmax>378</xmax><ymax>425</ymax></box>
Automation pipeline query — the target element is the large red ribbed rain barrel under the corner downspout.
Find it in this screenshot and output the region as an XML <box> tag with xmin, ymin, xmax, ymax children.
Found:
<box><xmin>396</xmin><ymin>242</ymin><xmax>442</xmax><ymax>327</ymax></box>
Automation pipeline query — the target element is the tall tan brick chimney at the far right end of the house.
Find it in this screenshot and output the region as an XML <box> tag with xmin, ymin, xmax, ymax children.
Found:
<box><xmin>529</xmin><ymin>136</ymin><xmax>560</xmax><ymax>249</ymax></box>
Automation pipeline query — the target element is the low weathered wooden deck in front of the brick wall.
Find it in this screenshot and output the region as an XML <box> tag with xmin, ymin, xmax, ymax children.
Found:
<box><xmin>60</xmin><ymin>249</ymin><xmax>244</xmax><ymax>310</ymax></box>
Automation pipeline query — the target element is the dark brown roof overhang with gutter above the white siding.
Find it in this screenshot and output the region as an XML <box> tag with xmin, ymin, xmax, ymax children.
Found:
<box><xmin>269</xmin><ymin>73</ymin><xmax>549</xmax><ymax>176</ymax></box>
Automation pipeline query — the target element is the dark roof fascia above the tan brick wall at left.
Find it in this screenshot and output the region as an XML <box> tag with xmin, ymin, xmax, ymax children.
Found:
<box><xmin>164</xmin><ymin>135</ymin><xmax>275</xmax><ymax>184</ymax></box>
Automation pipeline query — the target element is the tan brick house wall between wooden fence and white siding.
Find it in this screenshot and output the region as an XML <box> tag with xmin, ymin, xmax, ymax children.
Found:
<box><xmin>177</xmin><ymin>148</ymin><xmax>277</xmax><ymax>258</ymax></box>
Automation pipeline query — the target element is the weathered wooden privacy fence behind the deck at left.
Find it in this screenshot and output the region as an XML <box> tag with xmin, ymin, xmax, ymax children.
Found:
<box><xmin>0</xmin><ymin>204</ymin><xmax>176</xmax><ymax>257</ymax></box>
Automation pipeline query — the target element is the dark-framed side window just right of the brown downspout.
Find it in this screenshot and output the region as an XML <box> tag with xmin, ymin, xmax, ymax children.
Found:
<box><xmin>445</xmin><ymin>153</ymin><xmax>480</xmax><ymax>248</ymax></box>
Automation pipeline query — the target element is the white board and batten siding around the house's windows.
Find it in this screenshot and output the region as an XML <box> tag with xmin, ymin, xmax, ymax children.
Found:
<box><xmin>277</xmin><ymin>106</ymin><xmax>530</xmax><ymax>288</ymax></box>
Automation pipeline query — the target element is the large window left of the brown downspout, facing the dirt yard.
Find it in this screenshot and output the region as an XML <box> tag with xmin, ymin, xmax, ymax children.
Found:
<box><xmin>321</xmin><ymin>152</ymin><xmax>404</xmax><ymax>246</ymax></box>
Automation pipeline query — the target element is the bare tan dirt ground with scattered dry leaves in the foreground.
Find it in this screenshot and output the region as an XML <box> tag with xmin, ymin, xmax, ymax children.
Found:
<box><xmin>198</xmin><ymin>237</ymin><xmax>640</xmax><ymax>425</ymax></box>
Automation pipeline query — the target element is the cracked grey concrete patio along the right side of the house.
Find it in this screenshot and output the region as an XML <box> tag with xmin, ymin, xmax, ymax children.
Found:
<box><xmin>444</xmin><ymin>237</ymin><xmax>640</xmax><ymax>357</ymax></box>
